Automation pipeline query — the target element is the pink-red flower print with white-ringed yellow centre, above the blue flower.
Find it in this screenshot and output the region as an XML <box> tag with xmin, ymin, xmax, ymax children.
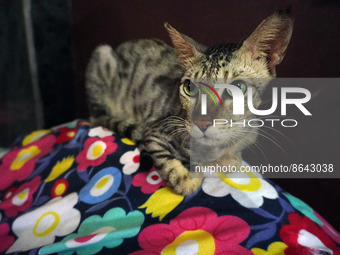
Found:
<box><xmin>76</xmin><ymin>136</ymin><xmax>117</xmax><ymax>171</ymax></box>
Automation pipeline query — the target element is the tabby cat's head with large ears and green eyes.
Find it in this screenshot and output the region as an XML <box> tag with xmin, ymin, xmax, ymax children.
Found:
<box><xmin>165</xmin><ymin>9</ymin><xmax>293</xmax><ymax>154</ymax></box>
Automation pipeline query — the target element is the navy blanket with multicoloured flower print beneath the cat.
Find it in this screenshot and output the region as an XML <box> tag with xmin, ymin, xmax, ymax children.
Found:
<box><xmin>0</xmin><ymin>120</ymin><xmax>340</xmax><ymax>255</ymax></box>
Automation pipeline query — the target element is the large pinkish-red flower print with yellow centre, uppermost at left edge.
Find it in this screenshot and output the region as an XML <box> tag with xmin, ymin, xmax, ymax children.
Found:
<box><xmin>0</xmin><ymin>135</ymin><xmax>56</xmax><ymax>190</ymax></box>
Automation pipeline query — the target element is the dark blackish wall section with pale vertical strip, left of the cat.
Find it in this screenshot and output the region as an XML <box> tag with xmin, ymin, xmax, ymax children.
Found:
<box><xmin>0</xmin><ymin>0</ymin><xmax>76</xmax><ymax>147</ymax></box>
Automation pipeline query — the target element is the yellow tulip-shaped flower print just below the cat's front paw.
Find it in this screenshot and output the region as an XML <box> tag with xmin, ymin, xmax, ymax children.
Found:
<box><xmin>139</xmin><ymin>187</ymin><xmax>184</xmax><ymax>220</ymax></box>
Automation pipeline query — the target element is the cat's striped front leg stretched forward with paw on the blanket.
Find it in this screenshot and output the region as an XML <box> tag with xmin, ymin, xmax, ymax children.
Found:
<box><xmin>140</xmin><ymin>134</ymin><xmax>203</xmax><ymax>196</ymax></box>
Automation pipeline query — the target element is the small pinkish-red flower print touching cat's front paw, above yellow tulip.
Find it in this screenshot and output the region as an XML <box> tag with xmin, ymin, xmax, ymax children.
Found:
<box><xmin>132</xmin><ymin>167</ymin><xmax>166</xmax><ymax>194</ymax></box>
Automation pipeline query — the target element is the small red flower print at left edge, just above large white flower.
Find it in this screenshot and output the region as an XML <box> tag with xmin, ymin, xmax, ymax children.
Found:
<box><xmin>0</xmin><ymin>176</ymin><xmax>41</xmax><ymax>217</ymax></box>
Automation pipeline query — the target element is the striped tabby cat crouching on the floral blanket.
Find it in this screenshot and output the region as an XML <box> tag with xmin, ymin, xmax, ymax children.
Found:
<box><xmin>86</xmin><ymin>8</ymin><xmax>294</xmax><ymax>196</ymax></box>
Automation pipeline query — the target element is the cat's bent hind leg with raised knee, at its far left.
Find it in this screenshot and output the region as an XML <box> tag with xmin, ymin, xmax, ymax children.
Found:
<box><xmin>86</xmin><ymin>45</ymin><xmax>142</xmax><ymax>142</ymax></box>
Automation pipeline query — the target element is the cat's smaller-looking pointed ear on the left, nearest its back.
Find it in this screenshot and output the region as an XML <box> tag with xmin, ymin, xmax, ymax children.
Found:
<box><xmin>164</xmin><ymin>23</ymin><xmax>208</xmax><ymax>68</ymax></box>
